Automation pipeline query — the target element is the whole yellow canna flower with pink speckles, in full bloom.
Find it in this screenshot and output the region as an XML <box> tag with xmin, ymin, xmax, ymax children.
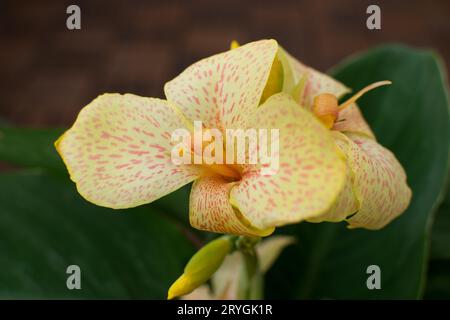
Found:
<box><xmin>55</xmin><ymin>40</ymin><xmax>411</xmax><ymax>236</ymax></box>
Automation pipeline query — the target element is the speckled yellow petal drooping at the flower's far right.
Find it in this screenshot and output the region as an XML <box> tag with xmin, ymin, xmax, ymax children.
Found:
<box><xmin>334</xmin><ymin>132</ymin><xmax>411</xmax><ymax>229</ymax></box>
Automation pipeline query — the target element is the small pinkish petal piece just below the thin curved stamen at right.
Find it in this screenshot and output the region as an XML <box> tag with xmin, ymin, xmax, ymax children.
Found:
<box><xmin>333</xmin><ymin>103</ymin><xmax>375</xmax><ymax>139</ymax></box>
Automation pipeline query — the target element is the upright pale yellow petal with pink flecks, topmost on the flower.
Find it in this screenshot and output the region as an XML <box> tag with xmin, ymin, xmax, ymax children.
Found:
<box><xmin>164</xmin><ymin>40</ymin><xmax>278</xmax><ymax>129</ymax></box>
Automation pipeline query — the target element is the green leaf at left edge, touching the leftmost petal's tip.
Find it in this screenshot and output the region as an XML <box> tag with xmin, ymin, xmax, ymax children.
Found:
<box><xmin>0</xmin><ymin>126</ymin><xmax>65</xmax><ymax>173</ymax></box>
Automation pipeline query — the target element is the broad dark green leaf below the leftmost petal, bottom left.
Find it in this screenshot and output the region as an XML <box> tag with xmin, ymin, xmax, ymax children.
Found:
<box><xmin>0</xmin><ymin>173</ymin><xmax>194</xmax><ymax>299</ymax></box>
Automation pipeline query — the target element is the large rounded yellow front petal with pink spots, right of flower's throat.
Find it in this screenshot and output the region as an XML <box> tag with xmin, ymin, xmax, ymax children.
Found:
<box><xmin>230</xmin><ymin>93</ymin><xmax>346</xmax><ymax>229</ymax></box>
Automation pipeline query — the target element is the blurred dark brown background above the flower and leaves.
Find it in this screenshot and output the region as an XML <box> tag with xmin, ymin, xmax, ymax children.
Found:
<box><xmin>0</xmin><ymin>0</ymin><xmax>450</xmax><ymax>127</ymax></box>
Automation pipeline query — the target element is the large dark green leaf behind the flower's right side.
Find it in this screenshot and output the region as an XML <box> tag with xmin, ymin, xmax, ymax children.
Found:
<box><xmin>266</xmin><ymin>45</ymin><xmax>449</xmax><ymax>299</ymax></box>
